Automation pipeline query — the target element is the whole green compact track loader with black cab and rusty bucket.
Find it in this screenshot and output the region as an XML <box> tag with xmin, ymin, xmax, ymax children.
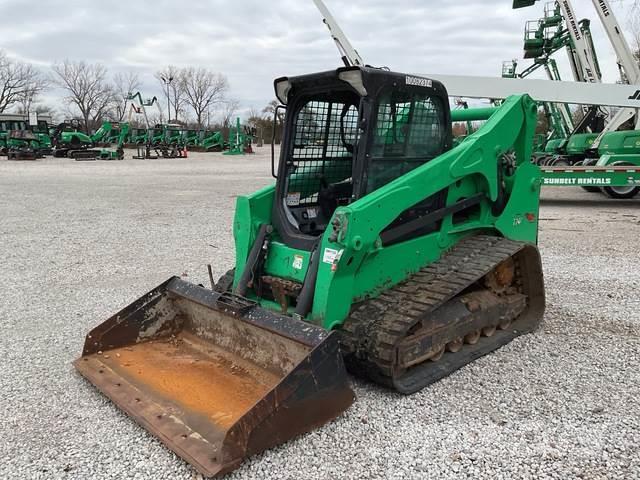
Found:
<box><xmin>75</xmin><ymin>67</ymin><xmax>544</xmax><ymax>475</ymax></box>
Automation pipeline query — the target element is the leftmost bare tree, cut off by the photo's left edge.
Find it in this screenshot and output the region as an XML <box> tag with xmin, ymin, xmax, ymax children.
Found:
<box><xmin>0</xmin><ymin>50</ymin><xmax>47</xmax><ymax>113</ymax></box>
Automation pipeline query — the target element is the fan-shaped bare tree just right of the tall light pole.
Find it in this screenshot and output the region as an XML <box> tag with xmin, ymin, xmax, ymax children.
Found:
<box><xmin>180</xmin><ymin>68</ymin><xmax>229</xmax><ymax>127</ymax></box>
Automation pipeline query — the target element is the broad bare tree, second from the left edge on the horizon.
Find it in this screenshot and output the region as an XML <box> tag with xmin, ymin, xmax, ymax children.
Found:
<box><xmin>53</xmin><ymin>60</ymin><xmax>114</xmax><ymax>132</ymax></box>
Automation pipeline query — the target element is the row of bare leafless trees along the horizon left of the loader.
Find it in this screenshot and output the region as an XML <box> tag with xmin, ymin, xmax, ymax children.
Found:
<box><xmin>0</xmin><ymin>50</ymin><xmax>239</xmax><ymax>132</ymax></box>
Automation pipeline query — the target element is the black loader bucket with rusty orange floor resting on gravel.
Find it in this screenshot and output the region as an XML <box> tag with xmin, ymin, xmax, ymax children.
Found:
<box><xmin>74</xmin><ymin>277</ymin><xmax>354</xmax><ymax>476</ymax></box>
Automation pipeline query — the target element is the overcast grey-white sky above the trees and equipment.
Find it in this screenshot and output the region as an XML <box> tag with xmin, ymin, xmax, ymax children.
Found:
<box><xmin>0</xmin><ymin>0</ymin><xmax>631</xmax><ymax>119</ymax></box>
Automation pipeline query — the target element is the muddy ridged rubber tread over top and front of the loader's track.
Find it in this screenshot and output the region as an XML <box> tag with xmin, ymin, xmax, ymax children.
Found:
<box><xmin>342</xmin><ymin>235</ymin><xmax>526</xmax><ymax>393</ymax></box>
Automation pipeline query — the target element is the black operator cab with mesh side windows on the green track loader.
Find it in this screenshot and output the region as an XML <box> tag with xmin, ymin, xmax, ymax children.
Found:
<box><xmin>273</xmin><ymin>67</ymin><xmax>452</xmax><ymax>250</ymax></box>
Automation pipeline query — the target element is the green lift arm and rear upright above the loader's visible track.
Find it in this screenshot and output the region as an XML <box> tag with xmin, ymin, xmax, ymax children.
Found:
<box><xmin>311</xmin><ymin>96</ymin><xmax>540</xmax><ymax>329</ymax></box>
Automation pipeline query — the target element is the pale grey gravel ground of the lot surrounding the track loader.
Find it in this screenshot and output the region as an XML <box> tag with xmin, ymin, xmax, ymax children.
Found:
<box><xmin>0</xmin><ymin>149</ymin><xmax>640</xmax><ymax>479</ymax></box>
